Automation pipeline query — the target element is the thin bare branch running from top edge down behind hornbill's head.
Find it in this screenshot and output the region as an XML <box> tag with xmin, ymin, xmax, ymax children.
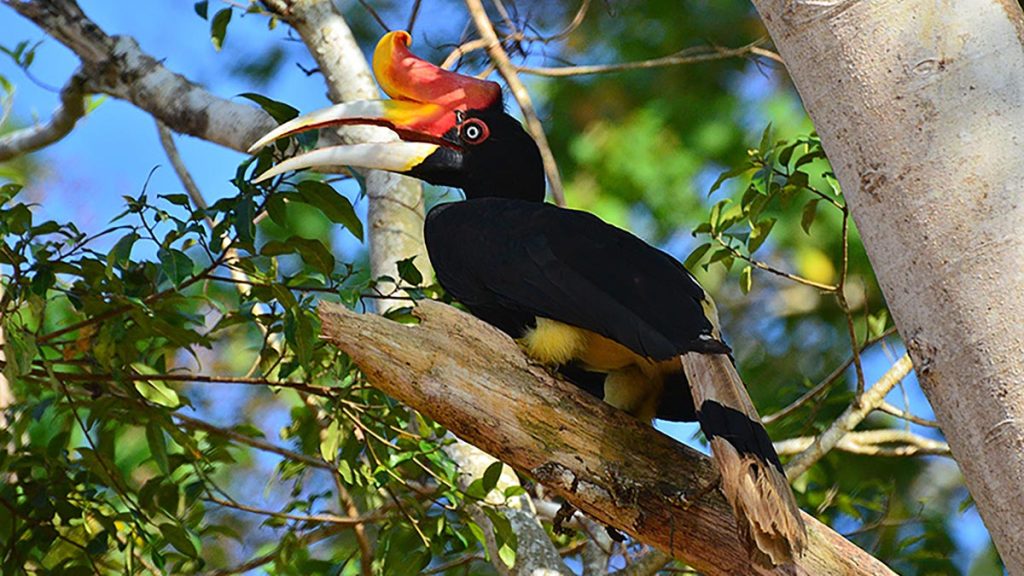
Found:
<box><xmin>466</xmin><ymin>0</ymin><xmax>565</xmax><ymax>206</ymax></box>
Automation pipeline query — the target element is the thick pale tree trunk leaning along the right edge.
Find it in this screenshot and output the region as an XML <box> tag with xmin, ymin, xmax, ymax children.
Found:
<box><xmin>754</xmin><ymin>0</ymin><xmax>1024</xmax><ymax>574</ymax></box>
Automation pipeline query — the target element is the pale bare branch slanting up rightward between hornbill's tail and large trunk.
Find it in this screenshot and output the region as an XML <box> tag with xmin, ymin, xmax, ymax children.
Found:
<box><xmin>785</xmin><ymin>354</ymin><xmax>913</xmax><ymax>479</ymax></box>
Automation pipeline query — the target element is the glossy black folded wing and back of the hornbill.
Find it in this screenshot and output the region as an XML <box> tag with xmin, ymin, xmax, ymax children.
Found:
<box><xmin>425</xmin><ymin>198</ymin><xmax>728</xmax><ymax>360</ymax></box>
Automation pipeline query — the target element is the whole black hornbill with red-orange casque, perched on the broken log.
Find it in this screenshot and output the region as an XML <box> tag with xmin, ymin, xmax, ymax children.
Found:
<box><xmin>251</xmin><ymin>31</ymin><xmax>805</xmax><ymax>564</ymax></box>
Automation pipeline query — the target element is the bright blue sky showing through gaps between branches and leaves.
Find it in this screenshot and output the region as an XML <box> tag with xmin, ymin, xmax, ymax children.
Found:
<box><xmin>0</xmin><ymin>0</ymin><xmax>987</xmax><ymax>566</ymax></box>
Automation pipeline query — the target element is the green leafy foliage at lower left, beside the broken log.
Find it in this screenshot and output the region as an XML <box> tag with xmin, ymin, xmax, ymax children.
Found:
<box><xmin>0</xmin><ymin>150</ymin><xmax>491</xmax><ymax>574</ymax></box>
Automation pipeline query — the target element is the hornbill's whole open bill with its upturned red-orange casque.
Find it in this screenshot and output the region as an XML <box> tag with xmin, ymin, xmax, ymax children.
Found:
<box><xmin>249</xmin><ymin>31</ymin><xmax>501</xmax><ymax>182</ymax></box>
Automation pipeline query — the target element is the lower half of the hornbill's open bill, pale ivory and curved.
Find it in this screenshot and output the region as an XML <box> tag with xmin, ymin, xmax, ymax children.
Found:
<box><xmin>253</xmin><ymin>141</ymin><xmax>440</xmax><ymax>183</ymax></box>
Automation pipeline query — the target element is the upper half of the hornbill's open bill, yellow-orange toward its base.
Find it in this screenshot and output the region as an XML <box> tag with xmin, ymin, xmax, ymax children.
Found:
<box><xmin>249</xmin><ymin>100</ymin><xmax>444</xmax><ymax>154</ymax></box>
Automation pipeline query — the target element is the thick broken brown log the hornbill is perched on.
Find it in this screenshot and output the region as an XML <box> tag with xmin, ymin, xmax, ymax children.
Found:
<box><xmin>319</xmin><ymin>301</ymin><xmax>892</xmax><ymax>575</ymax></box>
